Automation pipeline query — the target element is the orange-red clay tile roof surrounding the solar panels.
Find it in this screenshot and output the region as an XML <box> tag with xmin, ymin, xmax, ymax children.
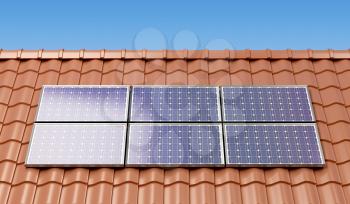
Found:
<box><xmin>0</xmin><ymin>50</ymin><xmax>350</xmax><ymax>203</ymax></box>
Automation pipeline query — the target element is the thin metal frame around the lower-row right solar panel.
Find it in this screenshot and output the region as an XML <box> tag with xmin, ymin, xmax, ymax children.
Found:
<box><xmin>223</xmin><ymin>123</ymin><xmax>325</xmax><ymax>168</ymax></box>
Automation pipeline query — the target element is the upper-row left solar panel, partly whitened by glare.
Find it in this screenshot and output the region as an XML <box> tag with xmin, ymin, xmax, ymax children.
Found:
<box><xmin>37</xmin><ymin>86</ymin><xmax>129</xmax><ymax>122</ymax></box>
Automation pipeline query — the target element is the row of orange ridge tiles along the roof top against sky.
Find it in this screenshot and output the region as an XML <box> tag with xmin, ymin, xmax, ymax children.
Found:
<box><xmin>0</xmin><ymin>49</ymin><xmax>350</xmax><ymax>59</ymax></box>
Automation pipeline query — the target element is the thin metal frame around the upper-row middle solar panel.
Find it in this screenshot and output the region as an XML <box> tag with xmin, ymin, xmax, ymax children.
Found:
<box><xmin>128</xmin><ymin>85</ymin><xmax>223</xmax><ymax>123</ymax></box>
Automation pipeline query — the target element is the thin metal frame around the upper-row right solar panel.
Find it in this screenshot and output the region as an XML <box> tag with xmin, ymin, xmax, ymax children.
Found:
<box><xmin>220</xmin><ymin>85</ymin><xmax>316</xmax><ymax>123</ymax></box>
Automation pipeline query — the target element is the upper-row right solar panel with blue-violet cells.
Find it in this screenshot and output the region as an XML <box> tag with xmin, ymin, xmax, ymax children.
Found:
<box><xmin>222</xmin><ymin>86</ymin><xmax>314</xmax><ymax>122</ymax></box>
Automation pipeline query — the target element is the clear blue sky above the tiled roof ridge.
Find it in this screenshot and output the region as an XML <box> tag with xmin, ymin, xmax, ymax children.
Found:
<box><xmin>0</xmin><ymin>0</ymin><xmax>350</xmax><ymax>49</ymax></box>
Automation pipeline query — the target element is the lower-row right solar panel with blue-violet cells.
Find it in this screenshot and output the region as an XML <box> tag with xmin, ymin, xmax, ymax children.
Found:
<box><xmin>224</xmin><ymin>124</ymin><xmax>324</xmax><ymax>167</ymax></box>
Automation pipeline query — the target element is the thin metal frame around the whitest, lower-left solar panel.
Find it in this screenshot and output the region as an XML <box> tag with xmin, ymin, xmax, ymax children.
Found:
<box><xmin>25</xmin><ymin>123</ymin><xmax>128</xmax><ymax>168</ymax></box>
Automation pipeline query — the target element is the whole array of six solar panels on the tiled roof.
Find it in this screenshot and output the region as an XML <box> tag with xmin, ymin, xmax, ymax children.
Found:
<box><xmin>26</xmin><ymin>86</ymin><xmax>324</xmax><ymax>167</ymax></box>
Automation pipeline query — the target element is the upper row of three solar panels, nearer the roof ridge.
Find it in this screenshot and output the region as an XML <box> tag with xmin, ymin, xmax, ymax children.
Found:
<box><xmin>36</xmin><ymin>86</ymin><xmax>314</xmax><ymax>122</ymax></box>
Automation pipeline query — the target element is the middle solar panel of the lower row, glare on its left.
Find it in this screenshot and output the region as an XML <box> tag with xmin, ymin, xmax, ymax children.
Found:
<box><xmin>126</xmin><ymin>123</ymin><xmax>224</xmax><ymax>167</ymax></box>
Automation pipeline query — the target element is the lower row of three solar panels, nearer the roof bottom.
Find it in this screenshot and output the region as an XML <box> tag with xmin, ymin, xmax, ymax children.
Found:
<box><xmin>26</xmin><ymin>123</ymin><xmax>324</xmax><ymax>167</ymax></box>
